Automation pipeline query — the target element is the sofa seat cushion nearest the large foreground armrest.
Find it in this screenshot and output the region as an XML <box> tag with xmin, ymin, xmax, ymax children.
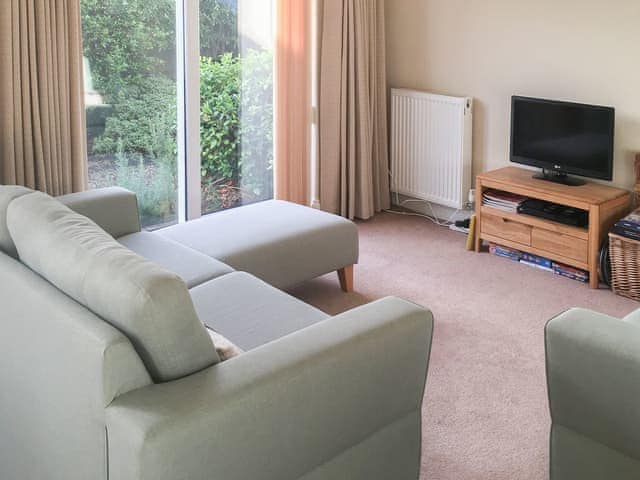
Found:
<box><xmin>190</xmin><ymin>272</ymin><xmax>329</xmax><ymax>351</ymax></box>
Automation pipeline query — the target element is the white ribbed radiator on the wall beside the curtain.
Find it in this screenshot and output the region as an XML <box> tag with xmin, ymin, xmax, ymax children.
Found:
<box><xmin>391</xmin><ymin>88</ymin><xmax>473</xmax><ymax>208</ymax></box>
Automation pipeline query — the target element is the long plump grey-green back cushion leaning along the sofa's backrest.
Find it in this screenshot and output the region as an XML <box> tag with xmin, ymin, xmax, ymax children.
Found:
<box><xmin>7</xmin><ymin>192</ymin><xmax>219</xmax><ymax>382</ymax></box>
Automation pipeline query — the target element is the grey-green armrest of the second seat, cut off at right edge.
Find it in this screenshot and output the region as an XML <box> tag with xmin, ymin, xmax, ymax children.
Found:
<box><xmin>545</xmin><ymin>308</ymin><xmax>640</xmax><ymax>458</ymax></box>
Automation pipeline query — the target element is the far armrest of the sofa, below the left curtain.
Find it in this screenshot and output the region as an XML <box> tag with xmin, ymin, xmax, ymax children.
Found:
<box><xmin>57</xmin><ymin>187</ymin><xmax>140</xmax><ymax>238</ymax></box>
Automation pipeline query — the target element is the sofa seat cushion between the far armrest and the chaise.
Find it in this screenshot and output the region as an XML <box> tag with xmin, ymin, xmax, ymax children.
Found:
<box><xmin>118</xmin><ymin>232</ymin><xmax>233</xmax><ymax>288</ymax></box>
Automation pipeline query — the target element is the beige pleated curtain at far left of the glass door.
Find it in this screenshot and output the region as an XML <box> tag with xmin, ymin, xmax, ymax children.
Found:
<box><xmin>0</xmin><ymin>0</ymin><xmax>87</xmax><ymax>195</ymax></box>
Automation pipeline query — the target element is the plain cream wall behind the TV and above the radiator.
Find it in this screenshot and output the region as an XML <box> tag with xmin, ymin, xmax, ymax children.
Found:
<box><xmin>386</xmin><ymin>0</ymin><xmax>640</xmax><ymax>191</ymax></box>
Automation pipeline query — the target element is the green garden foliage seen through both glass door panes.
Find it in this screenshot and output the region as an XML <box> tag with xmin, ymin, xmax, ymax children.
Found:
<box><xmin>81</xmin><ymin>0</ymin><xmax>273</xmax><ymax>224</ymax></box>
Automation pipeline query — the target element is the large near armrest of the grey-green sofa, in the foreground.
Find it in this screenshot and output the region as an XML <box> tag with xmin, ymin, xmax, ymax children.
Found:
<box><xmin>106</xmin><ymin>298</ymin><xmax>433</xmax><ymax>480</ymax></box>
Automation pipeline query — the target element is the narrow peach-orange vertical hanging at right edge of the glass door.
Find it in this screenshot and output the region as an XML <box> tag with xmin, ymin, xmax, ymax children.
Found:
<box><xmin>274</xmin><ymin>0</ymin><xmax>311</xmax><ymax>205</ymax></box>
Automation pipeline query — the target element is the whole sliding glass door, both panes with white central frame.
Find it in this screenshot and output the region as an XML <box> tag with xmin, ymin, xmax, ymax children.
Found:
<box><xmin>81</xmin><ymin>0</ymin><xmax>274</xmax><ymax>228</ymax></box>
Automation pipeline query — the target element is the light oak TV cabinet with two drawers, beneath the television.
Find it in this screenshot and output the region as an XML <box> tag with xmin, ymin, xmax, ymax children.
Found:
<box><xmin>475</xmin><ymin>167</ymin><xmax>631</xmax><ymax>288</ymax></box>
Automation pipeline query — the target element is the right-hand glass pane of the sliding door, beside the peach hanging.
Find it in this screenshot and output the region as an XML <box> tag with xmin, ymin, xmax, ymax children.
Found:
<box><xmin>200</xmin><ymin>0</ymin><xmax>273</xmax><ymax>213</ymax></box>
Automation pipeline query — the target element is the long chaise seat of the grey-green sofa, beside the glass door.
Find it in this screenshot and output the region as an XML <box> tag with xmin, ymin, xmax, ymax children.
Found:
<box><xmin>158</xmin><ymin>200</ymin><xmax>358</xmax><ymax>288</ymax></box>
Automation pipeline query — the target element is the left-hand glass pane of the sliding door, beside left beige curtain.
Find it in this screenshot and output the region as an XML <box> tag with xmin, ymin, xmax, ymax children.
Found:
<box><xmin>81</xmin><ymin>0</ymin><xmax>178</xmax><ymax>227</ymax></box>
